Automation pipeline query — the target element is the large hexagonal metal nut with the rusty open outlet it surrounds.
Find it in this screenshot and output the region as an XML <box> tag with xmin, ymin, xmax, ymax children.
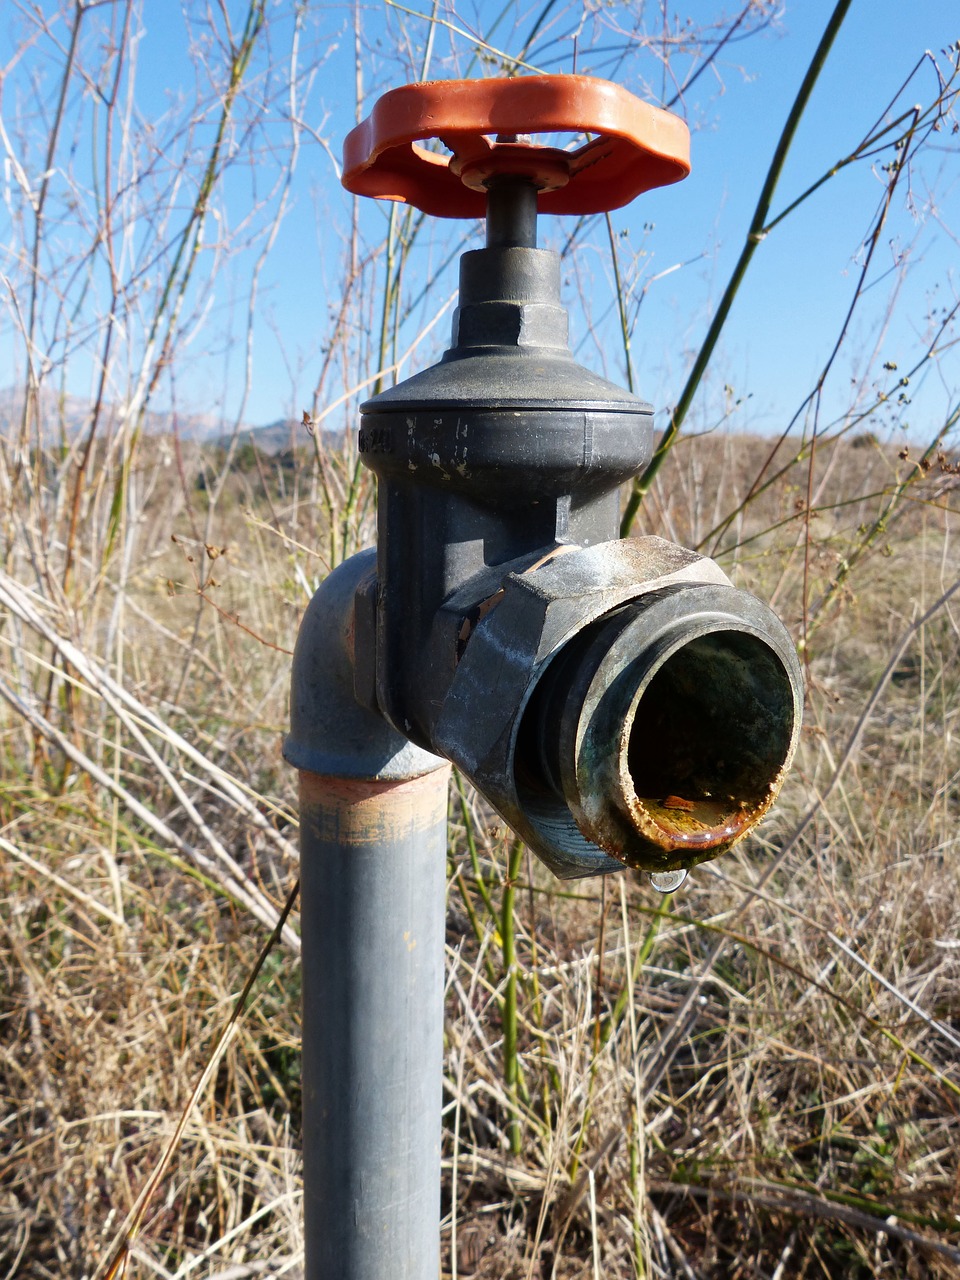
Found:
<box><xmin>434</xmin><ymin>538</ymin><xmax>803</xmax><ymax>878</ymax></box>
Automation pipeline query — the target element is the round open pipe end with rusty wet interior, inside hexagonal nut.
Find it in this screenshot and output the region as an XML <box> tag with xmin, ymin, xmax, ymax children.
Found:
<box><xmin>517</xmin><ymin>585</ymin><xmax>803</xmax><ymax>872</ymax></box>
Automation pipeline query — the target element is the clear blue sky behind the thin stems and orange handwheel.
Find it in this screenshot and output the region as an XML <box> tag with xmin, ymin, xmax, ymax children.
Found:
<box><xmin>0</xmin><ymin>0</ymin><xmax>960</xmax><ymax>445</ymax></box>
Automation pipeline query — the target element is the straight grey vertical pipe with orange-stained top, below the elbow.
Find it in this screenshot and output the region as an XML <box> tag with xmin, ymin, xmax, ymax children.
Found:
<box><xmin>300</xmin><ymin>768</ymin><xmax>449</xmax><ymax>1280</ymax></box>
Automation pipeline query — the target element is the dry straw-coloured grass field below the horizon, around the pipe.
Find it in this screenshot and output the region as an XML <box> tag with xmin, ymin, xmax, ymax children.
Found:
<box><xmin>0</xmin><ymin>422</ymin><xmax>960</xmax><ymax>1280</ymax></box>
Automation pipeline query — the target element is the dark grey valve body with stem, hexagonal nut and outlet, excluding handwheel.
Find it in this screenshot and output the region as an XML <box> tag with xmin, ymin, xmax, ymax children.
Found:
<box><xmin>345</xmin><ymin>178</ymin><xmax>803</xmax><ymax>877</ymax></box>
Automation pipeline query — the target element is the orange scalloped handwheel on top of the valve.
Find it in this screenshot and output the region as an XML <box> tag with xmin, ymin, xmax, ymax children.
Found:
<box><xmin>342</xmin><ymin>76</ymin><xmax>690</xmax><ymax>218</ymax></box>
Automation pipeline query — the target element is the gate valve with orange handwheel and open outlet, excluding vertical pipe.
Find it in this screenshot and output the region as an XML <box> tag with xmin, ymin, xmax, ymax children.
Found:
<box><xmin>287</xmin><ymin>76</ymin><xmax>803</xmax><ymax>891</ymax></box>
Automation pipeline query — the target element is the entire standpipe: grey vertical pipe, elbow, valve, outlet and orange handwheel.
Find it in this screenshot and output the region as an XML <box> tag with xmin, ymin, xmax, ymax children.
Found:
<box><xmin>284</xmin><ymin>85</ymin><xmax>803</xmax><ymax>1280</ymax></box>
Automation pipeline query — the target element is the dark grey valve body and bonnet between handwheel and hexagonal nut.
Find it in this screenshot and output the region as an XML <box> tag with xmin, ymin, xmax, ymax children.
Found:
<box><xmin>357</xmin><ymin>222</ymin><xmax>653</xmax><ymax>750</ymax></box>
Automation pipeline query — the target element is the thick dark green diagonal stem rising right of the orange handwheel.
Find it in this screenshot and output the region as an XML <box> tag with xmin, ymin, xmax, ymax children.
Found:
<box><xmin>620</xmin><ymin>0</ymin><xmax>852</xmax><ymax>538</ymax></box>
